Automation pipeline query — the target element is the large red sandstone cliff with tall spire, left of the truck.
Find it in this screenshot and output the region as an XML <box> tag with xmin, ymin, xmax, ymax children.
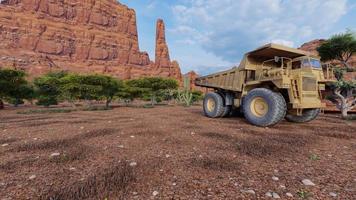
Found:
<box><xmin>0</xmin><ymin>0</ymin><xmax>182</xmax><ymax>80</ymax></box>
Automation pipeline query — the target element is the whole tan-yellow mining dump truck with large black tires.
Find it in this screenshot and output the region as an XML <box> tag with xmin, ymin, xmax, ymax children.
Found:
<box><xmin>195</xmin><ymin>44</ymin><xmax>328</xmax><ymax>127</ymax></box>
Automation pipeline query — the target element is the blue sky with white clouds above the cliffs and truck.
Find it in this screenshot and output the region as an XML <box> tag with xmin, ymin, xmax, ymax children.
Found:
<box><xmin>119</xmin><ymin>0</ymin><xmax>356</xmax><ymax>75</ymax></box>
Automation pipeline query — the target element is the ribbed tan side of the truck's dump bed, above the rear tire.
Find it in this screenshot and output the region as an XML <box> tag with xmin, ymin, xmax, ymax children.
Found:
<box><xmin>195</xmin><ymin>67</ymin><xmax>243</xmax><ymax>91</ymax></box>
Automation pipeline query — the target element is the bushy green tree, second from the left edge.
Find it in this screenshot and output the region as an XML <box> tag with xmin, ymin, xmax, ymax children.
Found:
<box><xmin>34</xmin><ymin>72</ymin><xmax>68</xmax><ymax>107</ymax></box>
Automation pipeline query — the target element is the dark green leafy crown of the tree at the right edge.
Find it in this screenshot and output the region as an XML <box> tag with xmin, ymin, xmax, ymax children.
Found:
<box><xmin>317</xmin><ymin>31</ymin><xmax>356</xmax><ymax>69</ymax></box>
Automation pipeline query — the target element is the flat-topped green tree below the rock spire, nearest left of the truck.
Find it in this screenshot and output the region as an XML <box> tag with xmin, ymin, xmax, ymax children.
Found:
<box><xmin>127</xmin><ymin>77</ymin><xmax>178</xmax><ymax>106</ymax></box>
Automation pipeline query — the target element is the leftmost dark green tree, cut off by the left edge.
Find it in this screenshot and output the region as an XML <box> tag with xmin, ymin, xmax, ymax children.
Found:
<box><xmin>0</xmin><ymin>69</ymin><xmax>33</xmax><ymax>109</ymax></box>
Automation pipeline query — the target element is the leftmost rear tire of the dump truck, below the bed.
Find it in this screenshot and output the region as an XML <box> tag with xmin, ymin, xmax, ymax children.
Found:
<box><xmin>203</xmin><ymin>92</ymin><xmax>225</xmax><ymax>118</ymax></box>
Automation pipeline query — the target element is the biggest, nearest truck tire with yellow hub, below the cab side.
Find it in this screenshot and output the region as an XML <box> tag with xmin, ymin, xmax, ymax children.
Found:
<box><xmin>242</xmin><ymin>88</ymin><xmax>287</xmax><ymax>127</ymax></box>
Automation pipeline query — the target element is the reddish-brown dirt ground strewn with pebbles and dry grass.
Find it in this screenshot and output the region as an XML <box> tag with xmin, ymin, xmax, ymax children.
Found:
<box><xmin>0</xmin><ymin>106</ymin><xmax>356</xmax><ymax>200</ymax></box>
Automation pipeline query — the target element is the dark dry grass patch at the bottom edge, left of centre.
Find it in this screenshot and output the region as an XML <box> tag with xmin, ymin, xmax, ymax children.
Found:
<box><xmin>39</xmin><ymin>163</ymin><xmax>136</xmax><ymax>200</ymax></box>
